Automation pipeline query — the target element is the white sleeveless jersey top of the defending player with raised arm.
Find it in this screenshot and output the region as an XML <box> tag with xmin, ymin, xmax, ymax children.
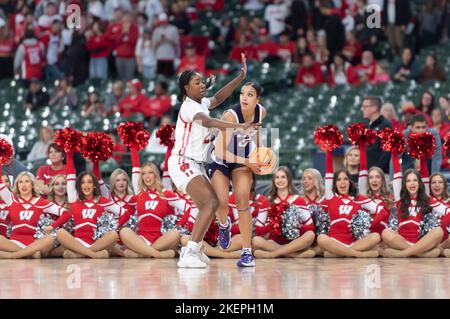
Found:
<box><xmin>172</xmin><ymin>97</ymin><xmax>212</xmax><ymax>162</ymax></box>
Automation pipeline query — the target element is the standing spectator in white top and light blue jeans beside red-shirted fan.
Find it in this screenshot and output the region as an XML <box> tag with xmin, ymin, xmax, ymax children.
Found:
<box><xmin>135</xmin><ymin>30</ymin><xmax>156</xmax><ymax>80</ymax></box>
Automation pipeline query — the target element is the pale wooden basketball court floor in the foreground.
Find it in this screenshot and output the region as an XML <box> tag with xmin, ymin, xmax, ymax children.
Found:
<box><xmin>0</xmin><ymin>258</ymin><xmax>450</xmax><ymax>299</ymax></box>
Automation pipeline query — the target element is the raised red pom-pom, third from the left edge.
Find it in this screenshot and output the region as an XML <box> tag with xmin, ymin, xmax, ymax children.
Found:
<box><xmin>81</xmin><ymin>132</ymin><xmax>114</xmax><ymax>162</ymax></box>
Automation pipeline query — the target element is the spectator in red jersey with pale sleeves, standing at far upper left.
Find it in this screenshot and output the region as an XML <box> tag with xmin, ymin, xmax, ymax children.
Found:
<box><xmin>14</xmin><ymin>29</ymin><xmax>45</xmax><ymax>81</ymax></box>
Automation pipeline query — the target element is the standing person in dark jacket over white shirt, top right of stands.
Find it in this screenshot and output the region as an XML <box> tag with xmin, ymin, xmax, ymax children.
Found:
<box><xmin>382</xmin><ymin>0</ymin><xmax>412</xmax><ymax>55</ymax></box>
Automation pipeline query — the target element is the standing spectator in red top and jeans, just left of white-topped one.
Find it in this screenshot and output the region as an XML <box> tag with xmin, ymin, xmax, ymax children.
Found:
<box><xmin>114</xmin><ymin>13</ymin><xmax>139</xmax><ymax>81</ymax></box>
